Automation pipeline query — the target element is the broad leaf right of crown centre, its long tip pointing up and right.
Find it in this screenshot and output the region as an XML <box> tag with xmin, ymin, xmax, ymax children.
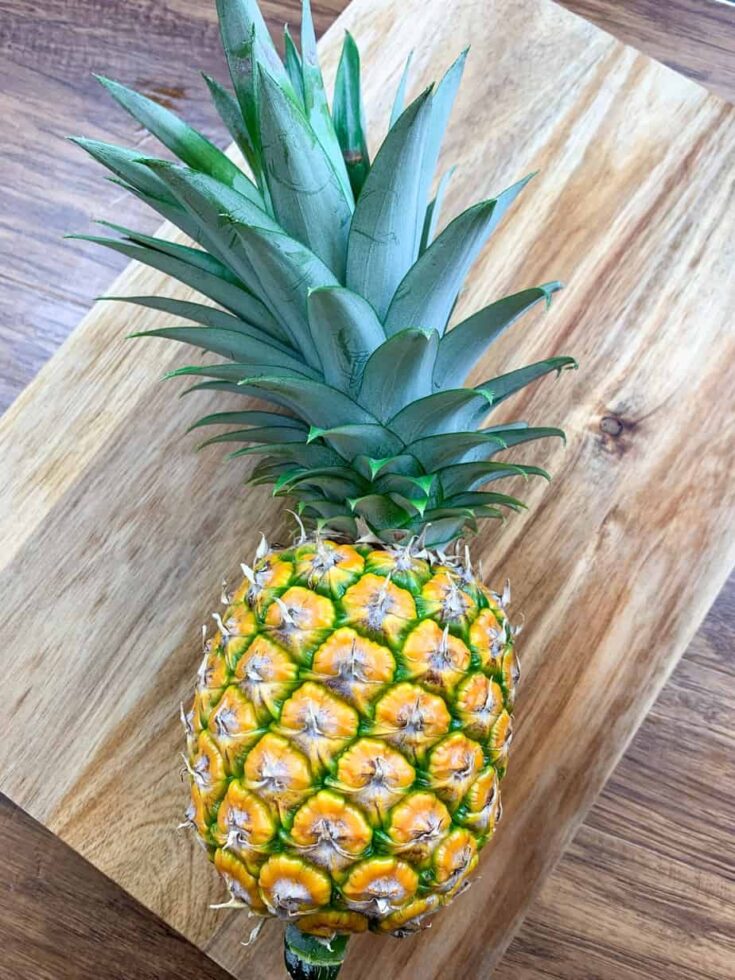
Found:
<box><xmin>385</xmin><ymin>174</ymin><xmax>533</xmax><ymax>335</ymax></box>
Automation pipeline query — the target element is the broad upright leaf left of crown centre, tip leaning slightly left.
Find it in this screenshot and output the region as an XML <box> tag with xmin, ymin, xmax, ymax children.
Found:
<box><xmin>260</xmin><ymin>66</ymin><xmax>352</xmax><ymax>280</ymax></box>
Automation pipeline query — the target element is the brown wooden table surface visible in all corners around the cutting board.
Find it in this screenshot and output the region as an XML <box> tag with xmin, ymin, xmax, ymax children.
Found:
<box><xmin>0</xmin><ymin>0</ymin><xmax>735</xmax><ymax>980</ymax></box>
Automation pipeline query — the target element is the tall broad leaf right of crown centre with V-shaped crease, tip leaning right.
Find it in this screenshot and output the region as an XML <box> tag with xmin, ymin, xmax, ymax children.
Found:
<box><xmin>347</xmin><ymin>89</ymin><xmax>431</xmax><ymax>318</ymax></box>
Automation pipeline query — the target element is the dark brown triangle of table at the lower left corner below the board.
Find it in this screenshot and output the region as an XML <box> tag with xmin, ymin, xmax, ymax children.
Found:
<box><xmin>0</xmin><ymin>795</ymin><xmax>230</xmax><ymax>980</ymax></box>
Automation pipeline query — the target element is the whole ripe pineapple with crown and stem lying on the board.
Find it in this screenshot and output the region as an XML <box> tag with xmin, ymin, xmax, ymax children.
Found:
<box><xmin>78</xmin><ymin>0</ymin><xmax>575</xmax><ymax>977</ymax></box>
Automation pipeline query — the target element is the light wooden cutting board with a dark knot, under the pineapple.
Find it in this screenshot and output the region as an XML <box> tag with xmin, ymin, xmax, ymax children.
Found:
<box><xmin>0</xmin><ymin>0</ymin><xmax>735</xmax><ymax>980</ymax></box>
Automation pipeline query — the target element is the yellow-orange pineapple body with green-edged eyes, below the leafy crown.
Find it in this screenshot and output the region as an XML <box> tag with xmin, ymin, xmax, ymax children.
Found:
<box><xmin>182</xmin><ymin>539</ymin><xmax>519</xmax><ymax>937</ymax></box>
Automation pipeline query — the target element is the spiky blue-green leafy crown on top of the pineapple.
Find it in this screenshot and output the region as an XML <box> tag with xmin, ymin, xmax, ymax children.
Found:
<box><xmin>74</xmin><ymin>0</ymin><xmax>576</xmax><ymax>547</ymax></box>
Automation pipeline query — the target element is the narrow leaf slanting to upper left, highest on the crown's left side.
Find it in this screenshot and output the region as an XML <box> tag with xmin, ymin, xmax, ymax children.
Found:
<box><xmin>95</xmin><ymin>75</ymin><xmax>263</xmax><ymax>207</ymax></box>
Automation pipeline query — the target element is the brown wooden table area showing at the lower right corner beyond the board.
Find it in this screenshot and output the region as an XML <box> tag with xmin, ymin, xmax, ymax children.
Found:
<box><xmin>493</xmin><ymin>576</ymin><xmax>735</xmax><ymax>980</ymax></box>
